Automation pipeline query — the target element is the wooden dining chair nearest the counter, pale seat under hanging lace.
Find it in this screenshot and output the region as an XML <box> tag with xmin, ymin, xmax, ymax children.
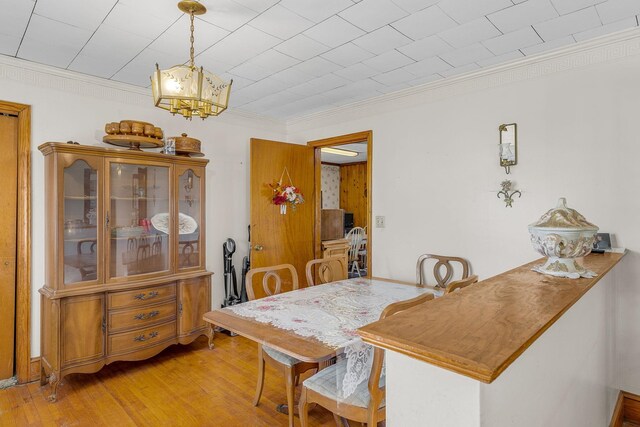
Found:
<box><xmin>299</xmin><ymin>293</ymin><xmax>433</xmax><ymax>427</ymax></box>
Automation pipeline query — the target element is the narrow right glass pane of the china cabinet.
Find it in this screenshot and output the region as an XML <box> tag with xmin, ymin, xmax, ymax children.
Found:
<box><xmin>178</xmin><ymin>169</ymin><xmax>201</xmax><ymax>269</ymax></box>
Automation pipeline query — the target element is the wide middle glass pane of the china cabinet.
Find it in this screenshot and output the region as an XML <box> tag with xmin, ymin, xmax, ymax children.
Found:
<box><xmin>108</xmin><ymin>163</ymin><xmax>171</xmax><ymax>277</ymax></box>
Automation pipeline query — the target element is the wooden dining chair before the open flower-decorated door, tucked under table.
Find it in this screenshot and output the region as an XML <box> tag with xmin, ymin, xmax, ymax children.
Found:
<box><xmin>246</xmin><ymin>264</ymin><xmax>318</xmax><ymax>427</ymax></box>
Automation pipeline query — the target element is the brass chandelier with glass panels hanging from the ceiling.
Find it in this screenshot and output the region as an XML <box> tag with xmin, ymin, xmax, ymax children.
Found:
<box><xmin>151</xmin><ymin>0</ymin><xmax>233</xmax><ymax>120</ymax></box>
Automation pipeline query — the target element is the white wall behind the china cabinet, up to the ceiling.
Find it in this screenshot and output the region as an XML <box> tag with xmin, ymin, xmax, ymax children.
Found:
<box><xmin>0</xmin><ymin>59</ymin><xmax>285</xmax><ymax>356</ymax></box>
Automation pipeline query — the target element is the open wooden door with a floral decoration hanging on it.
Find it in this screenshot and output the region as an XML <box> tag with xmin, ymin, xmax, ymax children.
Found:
<box><xmin>250</xmin><ymin>139</ymin><xmax>315</xmax><ymax>290</ymax></box>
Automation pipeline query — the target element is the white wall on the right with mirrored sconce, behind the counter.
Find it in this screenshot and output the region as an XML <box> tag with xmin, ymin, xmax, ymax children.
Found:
<box><xmin>288</xmin><ymin>31</ymin><xmax>640</xmax><ymax>393</ymax></box>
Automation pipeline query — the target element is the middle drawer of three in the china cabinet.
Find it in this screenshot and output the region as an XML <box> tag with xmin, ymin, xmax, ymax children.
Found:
<box><xmin>109</xmin><ymin>300</ymin><xmax>176</xmax><ymax>333</ymax></box>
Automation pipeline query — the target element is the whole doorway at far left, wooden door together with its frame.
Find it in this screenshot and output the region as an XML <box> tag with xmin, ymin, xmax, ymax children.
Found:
<box><xmin>0</xmin><ymin>101</ymin><xmax>31</xmax><ymax>383</ymax></box>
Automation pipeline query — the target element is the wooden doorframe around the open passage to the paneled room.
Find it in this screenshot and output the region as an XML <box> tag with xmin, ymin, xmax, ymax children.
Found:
<box><xmin>307</xmin><ymin>130</ymin><xmax>373</xmax><ymax>277</ymax></box>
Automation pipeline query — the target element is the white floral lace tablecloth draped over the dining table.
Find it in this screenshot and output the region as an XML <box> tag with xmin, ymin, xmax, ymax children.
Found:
<box><xmin>223</xmin><ymin>279</ymin><xmax>433</xmax><ymax>397</ymax></box>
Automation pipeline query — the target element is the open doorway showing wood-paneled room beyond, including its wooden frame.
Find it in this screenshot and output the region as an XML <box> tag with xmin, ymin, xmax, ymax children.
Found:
<box><xmin>307</xmin><ymin>130</ymin><xmax>373</xmax><ymax>277</ymax></box>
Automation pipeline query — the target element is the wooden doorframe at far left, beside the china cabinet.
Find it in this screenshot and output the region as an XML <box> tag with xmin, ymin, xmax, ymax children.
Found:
<box><xmin>0</xmin><ymin>100</ymin><xmax>31</xmax><ymax>383</ymax></box>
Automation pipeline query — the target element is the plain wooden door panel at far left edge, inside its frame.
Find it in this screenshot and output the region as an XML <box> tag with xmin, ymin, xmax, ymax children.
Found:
<box><xmin>0</xmin><ymin>115</ymin><xmax>18</xmax><ymax>379</ymax></box>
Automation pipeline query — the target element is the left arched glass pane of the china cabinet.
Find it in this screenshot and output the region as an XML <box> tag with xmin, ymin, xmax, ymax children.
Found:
<box><xmin>63</xmin><ymin>160</ymin><xmax>98</xmax><ymax>284</ymax></box>
